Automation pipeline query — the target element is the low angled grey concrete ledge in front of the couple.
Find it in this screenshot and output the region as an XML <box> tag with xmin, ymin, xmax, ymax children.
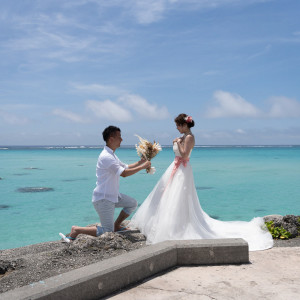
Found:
<box><xmin>1</xmin><ymin>239</ymin><xmax>249</xmax><ymax>300</ymax></box>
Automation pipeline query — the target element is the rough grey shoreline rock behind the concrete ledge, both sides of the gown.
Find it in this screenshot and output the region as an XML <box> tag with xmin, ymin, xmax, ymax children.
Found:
<box><xmin>0</xmin><ymin>215</ymin><xmax>300</xmax><ymax>293</ymax></box>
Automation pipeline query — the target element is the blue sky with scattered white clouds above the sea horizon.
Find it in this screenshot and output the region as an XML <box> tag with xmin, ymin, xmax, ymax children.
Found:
<box><xmin>0</xmin><ymin>0</ymin><xmax>300</xmax><ymax>145</ymax></box>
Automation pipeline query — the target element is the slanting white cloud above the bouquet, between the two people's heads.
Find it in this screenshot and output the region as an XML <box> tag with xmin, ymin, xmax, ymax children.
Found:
<box><xmin>119</xmin><ymin>94</ymin><xmax>169</xmax><ymax>120</ymax></box>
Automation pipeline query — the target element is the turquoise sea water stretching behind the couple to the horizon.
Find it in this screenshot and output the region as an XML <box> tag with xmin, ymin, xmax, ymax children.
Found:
<box><xmin>0</xmin><ymin>146</ymin><xmax>300</xmax><ymax>249</ymax></box>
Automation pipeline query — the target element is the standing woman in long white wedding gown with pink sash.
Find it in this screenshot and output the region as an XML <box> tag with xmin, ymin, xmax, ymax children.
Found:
<box><xmin>129</xmin><ymin>114</ymin><xmax>273</xmax><ymax>251</ymax></box>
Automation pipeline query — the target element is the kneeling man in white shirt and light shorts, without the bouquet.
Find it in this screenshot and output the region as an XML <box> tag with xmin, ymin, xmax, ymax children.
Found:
<box><xmin>67</xmin><ymin>126</ymin><xmax>151</xmax><ymax>239</ymax></box>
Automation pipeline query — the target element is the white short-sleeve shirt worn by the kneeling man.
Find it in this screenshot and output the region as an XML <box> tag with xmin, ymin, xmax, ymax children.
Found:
<box><xmin>92</xmin><ymin>146</ymin><xmax>128</xmax><ymax>203</ymax></box>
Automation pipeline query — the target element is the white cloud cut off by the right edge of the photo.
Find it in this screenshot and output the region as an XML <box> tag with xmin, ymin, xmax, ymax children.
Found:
<box><xmin>268</xmin><ymin>97</ymin><xmax>300</xmax><ymax>118</ymax></box>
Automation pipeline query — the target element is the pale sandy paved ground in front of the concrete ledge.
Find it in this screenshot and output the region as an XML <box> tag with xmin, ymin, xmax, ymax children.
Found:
<box><xmin>106</xmin><ymin>247</ymin><xmax>300</xmax><ymax>300</ymax></box>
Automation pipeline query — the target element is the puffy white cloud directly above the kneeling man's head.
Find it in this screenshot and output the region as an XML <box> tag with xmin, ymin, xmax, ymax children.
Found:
<box><xmin>86</xmin><ymin>100</ymin><xmax>132</xmax><ymax>122</ymax></box>
